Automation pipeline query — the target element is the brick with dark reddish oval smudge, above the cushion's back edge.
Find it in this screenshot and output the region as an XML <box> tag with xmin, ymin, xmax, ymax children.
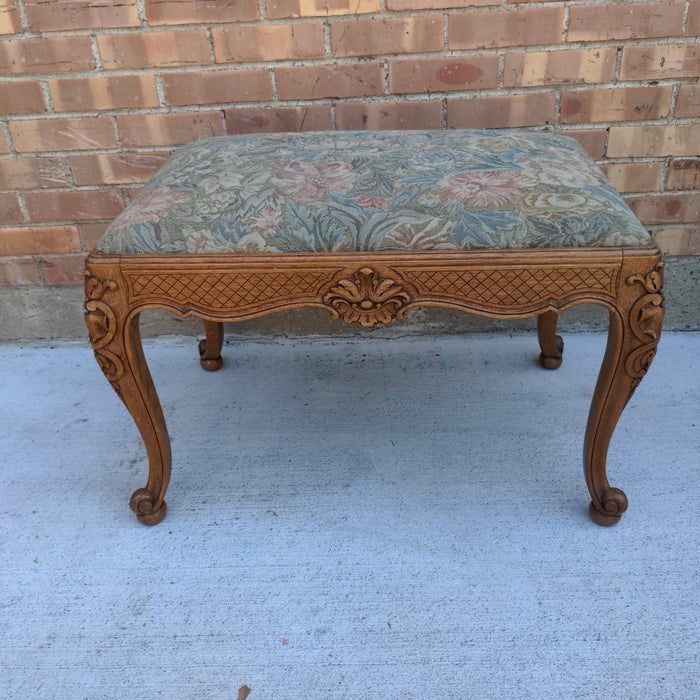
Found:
<box><xmin>389</xmin><ymin>56</ymin><xmax>498</xmax><ymax>93</ymax></box>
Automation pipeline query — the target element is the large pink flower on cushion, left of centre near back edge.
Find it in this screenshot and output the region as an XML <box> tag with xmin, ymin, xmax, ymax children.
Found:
<box><xmin>270</xmin><ymin>161</ymin><xmax>358</xmax><ymax>202</ymax></box>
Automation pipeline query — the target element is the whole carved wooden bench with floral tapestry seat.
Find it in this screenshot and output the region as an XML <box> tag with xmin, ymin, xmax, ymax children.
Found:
<box><xmin>85</xmin><ymin>130</ymin><xmax>663</xmax><ymax>525</ymax></box>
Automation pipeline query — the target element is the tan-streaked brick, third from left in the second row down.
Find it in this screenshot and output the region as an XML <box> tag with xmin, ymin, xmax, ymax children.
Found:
<box><xmin>212</xmin><ymin>22</ymin><xmax>325</xmax><ymax>63</ymax></box>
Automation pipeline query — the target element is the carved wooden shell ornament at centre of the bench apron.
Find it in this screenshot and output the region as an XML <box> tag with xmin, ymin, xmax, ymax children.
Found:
<box><xmin>323</xmin><ymin>267</ymin><xmax>411</xmax><ymax>326</ymax></box>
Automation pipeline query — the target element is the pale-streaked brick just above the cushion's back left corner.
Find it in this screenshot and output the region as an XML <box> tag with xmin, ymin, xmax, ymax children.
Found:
<box><xmin>117</xmin><ymin>112</ymin><xmax>223</xmax><ymax>148</ymax></box>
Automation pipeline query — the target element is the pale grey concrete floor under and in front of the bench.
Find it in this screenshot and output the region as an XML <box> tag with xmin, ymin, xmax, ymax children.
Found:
<box><xmin>0</xmin><ymin>334</ymin><xmax>700</xmax><ymax>700</ymax></box>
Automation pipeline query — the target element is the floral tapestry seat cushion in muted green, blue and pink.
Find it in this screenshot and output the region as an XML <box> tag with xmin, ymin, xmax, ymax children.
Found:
<box><xmin>97</xmin><ymin>130</ymin><xmax>652</xmax><ymax>255</ymax></box>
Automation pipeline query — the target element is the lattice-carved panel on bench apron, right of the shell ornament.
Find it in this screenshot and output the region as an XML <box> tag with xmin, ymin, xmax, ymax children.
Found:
<box><xmin>404</xmin><ymin>266</ymin><xmax>617</xmax><ymax>306</ymax></box>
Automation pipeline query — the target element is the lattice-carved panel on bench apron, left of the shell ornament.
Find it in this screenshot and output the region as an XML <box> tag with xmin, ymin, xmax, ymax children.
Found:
<box><xmin>129</xmin><ymin>270</ymin><xmax>331</xmax><ymax>309</ymax></box>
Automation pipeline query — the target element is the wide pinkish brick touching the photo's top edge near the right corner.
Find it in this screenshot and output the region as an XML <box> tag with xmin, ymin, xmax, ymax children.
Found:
<box><xmin>568</xmin><ymin>2</ymin><xmax>685</xmax><ymax>41</ymax></box>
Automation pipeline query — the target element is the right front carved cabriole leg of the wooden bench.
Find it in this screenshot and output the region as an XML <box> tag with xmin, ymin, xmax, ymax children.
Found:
<box><xmin>583</xmin><ymin>263</ymin><xmax>664</xmax><ymax>525</ymax></box>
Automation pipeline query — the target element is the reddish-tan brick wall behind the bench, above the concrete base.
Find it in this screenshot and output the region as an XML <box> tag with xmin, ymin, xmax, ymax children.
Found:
<box><xmin>0</xmin><ymin>0</ymin><xmax>700</xmax><ymax>287</ymax></box>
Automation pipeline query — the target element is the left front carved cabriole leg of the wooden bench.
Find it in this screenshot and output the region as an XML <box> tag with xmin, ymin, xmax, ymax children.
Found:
<box><xmin>85</xmin><ymin>271</ymin><xmax>171</xmax><ymax>525</ymax></box>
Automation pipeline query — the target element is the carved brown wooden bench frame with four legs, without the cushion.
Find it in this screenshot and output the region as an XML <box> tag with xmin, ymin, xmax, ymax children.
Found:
<box><xmin>85</xmin><ymin>247</ymin><xmax>664</xmax><ymax>525</ymax></box>
